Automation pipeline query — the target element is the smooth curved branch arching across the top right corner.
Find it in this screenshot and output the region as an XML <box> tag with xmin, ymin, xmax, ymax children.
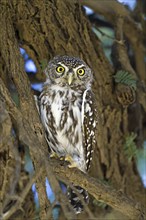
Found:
<box><xmin>81</xmin><ymin>0</ymin><xmax>146</xmax><ymax>83</ymax></box>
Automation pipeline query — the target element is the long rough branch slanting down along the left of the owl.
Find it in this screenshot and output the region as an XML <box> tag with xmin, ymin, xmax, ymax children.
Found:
<box><xmin>0</xmin><ymin>7</ymin><xmax>49</xmax><ymax>219</ymax></box>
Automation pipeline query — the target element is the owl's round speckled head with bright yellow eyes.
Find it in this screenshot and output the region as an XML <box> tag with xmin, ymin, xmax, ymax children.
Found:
<box><xmin>45</xmin><ymin>56</ymin><xmax>93</xmax><ymax>88</ymax></box>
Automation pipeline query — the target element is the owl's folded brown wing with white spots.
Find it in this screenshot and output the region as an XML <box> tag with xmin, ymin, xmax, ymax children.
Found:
<box><xmin>82</xmin><ymin>90</ymin><xmax>98</xmax><ymax>170</ymax></box>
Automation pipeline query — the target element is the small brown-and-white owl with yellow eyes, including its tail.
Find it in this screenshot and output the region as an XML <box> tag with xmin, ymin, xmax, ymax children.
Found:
<box><xmin>39</xmin><ymin>56</ymin><xmax>97</xmax><ymax>213</ymax></box>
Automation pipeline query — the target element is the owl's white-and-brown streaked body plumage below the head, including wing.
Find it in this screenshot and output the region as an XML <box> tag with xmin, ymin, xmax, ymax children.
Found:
<box><xmin>40</xmin><ymin>85</ymin><xmax>97</xmax><ymax>172</ymax></box>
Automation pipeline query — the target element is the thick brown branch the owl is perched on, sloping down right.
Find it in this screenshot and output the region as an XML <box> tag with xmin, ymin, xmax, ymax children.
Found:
<box><xmin>49</xmin><ymin>159</ymin><xmax>144</xmax><ymax>220</ymax></box>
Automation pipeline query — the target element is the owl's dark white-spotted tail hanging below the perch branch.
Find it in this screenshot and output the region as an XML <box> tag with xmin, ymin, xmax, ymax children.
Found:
<box><xmin>67</xmin><ymin>186</ymin><xmax>89</xmax><ymax>214</ymax></box>
